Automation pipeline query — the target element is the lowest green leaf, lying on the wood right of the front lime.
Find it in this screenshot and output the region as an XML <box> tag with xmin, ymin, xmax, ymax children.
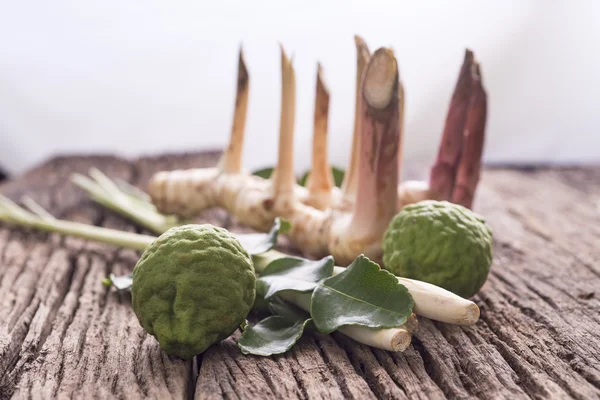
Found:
<box><xmin>237</xmin><ymin>315</ymin><xmax>310</xmax><ymax>357</ymax></box>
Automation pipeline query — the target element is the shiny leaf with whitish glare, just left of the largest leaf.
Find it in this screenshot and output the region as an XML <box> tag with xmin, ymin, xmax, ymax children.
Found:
<box><xmin>257</xmin><ymin>256</ymin><xmax>334</xmax><ymax>299</ymax></box>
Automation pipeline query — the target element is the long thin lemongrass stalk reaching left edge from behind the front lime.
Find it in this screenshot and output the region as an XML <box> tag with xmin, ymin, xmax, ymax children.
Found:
<box><xmin>0</xmin><ymin>195</ymin><xmax>156</xmax><ymax>250</ymax></box>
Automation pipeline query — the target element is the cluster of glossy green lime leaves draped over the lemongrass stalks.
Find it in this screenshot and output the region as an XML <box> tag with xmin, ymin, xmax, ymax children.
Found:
<box><xmin>238</xmin><ymin>255</ymin><xmax>414</xmax><ymax>355</ymax></box>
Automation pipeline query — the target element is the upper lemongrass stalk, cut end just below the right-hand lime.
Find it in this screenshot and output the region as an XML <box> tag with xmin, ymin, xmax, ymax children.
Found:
<box><xmin>254</xmin><ymin>250</ymin><xmax>479</xmax><ymax>326</ymax></box>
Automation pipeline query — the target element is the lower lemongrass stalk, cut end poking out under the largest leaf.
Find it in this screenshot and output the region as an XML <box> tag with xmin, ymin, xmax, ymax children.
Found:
<box><xmin>279</xmin><ymin>291</ymin><xmax>416</xmax><ymax>351</ymax></box>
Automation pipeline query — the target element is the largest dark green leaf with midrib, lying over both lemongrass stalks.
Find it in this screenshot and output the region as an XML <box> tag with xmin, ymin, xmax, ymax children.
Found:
<box><xmin>310</xmin><ymin>255</ymin><xmax>414</xmax><ymax>333</ymax></box>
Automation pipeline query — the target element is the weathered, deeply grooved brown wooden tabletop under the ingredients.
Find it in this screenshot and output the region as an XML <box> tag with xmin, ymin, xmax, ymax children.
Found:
<box><xmin>0</xmin><ymin>154</ymin><xmax>600</xmax><ymax>399</ymax></box>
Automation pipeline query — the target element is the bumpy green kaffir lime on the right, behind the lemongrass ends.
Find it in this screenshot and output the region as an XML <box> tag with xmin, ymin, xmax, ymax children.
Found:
<box><xmin>383</xmin><ymin>200</ymin><xmax>492</xmax><ymax>298</ymax></box>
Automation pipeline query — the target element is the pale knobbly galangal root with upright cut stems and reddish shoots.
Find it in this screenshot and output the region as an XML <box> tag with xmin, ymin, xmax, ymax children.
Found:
<box><xmin>148</xmin><ymin>37</ymin><xmax>487</xmax><ymax>265</ymax></box>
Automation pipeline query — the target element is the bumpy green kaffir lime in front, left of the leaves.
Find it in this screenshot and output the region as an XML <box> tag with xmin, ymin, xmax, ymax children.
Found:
<box><xmin>131</xmin><ymin>224</ymin><xmax>256</xmax><ymax>360</ymax></box>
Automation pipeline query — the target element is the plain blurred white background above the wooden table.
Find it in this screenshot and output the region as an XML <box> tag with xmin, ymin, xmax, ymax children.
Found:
<box><xmin>0</xmin><ymin>0</ymin><xmax>600</xmax><ymax>173</ymax></box>
